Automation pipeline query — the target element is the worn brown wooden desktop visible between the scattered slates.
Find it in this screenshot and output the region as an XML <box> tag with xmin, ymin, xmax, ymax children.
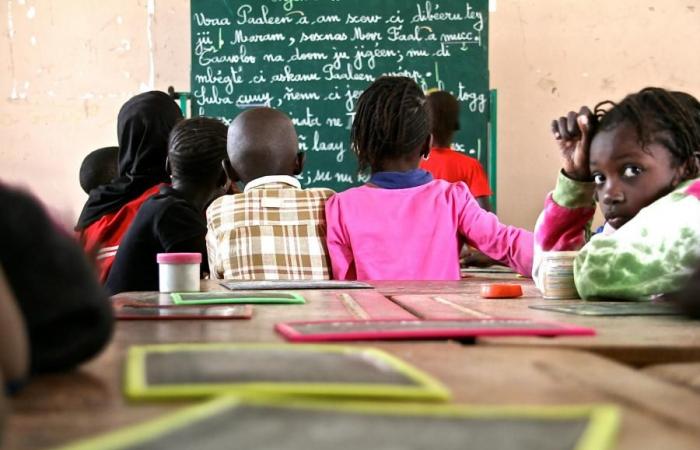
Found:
<box><xmin>3</xmin><ymin>278</ymin><xmax>700</xmax><ymax>450</ymax></box>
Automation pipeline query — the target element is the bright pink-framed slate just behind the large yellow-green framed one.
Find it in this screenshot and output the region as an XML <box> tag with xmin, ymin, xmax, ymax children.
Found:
<box><xmin>275</xmin><ymin>318</ymin><xmax>595</xmax><ymax>342</ymax></box>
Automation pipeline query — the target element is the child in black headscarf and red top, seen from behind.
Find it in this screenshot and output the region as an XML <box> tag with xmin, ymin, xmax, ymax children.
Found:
<box><xmin>75</xmin><ymin>91</ymin><xmax>182</xmax><ymax>282</ymax></box>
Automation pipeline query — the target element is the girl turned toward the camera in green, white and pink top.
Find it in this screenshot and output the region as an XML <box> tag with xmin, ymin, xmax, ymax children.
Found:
<box><xmin>533</xmin><ymin>88</ymin><xmax>700</xmax><ymax>300</ymax></box>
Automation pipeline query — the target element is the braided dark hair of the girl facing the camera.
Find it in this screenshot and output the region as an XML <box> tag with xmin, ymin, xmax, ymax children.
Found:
<box><xmin>595</xmin><ymin>87</ymin><xmax>700</xmax><ymax>178</ymax></box>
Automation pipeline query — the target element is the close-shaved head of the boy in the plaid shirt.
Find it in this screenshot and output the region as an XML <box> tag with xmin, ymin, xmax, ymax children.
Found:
<box><xmin>224</xmin><ymin>108</ymin><xmax>303</xmax><ymax>183</ymax></box>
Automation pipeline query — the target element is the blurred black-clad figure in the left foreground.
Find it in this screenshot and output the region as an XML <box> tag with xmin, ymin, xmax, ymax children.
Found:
<box><xmin>0</xmin><ymin>183</ymin><xmax>114</xmax><ymax>376</ymax></box>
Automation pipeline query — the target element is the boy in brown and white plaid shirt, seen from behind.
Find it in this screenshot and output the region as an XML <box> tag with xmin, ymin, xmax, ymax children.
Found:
<box><xmin>207</xmin><ymin>108</ymin><xmax>333</xmax><ymax>280</ymax></box>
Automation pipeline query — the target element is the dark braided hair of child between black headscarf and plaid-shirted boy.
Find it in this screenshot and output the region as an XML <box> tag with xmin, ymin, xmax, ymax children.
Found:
<box><xmin>168</xmin><ymin>117</ymin><xmax>228</xmax><ymax>181</ymax></box>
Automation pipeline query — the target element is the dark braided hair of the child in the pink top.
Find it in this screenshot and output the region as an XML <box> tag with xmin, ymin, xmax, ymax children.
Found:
<box><xmin>350</xmin><ymin>77</ymin><xmax>429</xmax><ymax>171</ymax></box>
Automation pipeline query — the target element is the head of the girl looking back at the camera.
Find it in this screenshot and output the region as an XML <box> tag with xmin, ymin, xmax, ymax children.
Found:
<box><xmin>590</xmin><ymin>88</ymin><xmax>700</xmax><ymax>228</ymax></box>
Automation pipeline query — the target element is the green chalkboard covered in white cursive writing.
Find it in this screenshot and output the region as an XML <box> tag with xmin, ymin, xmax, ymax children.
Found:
<box><xmin>191</xmin><ymin>0</ymin><xmax>489</xmax><ymax>190</ymax></box>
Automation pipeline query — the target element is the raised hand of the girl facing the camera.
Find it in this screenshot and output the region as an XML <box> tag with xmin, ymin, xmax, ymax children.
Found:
<box><xmin>552</xmin><ymin>106</ymin><xmax>595</xmax><ymax>181</ymax></box>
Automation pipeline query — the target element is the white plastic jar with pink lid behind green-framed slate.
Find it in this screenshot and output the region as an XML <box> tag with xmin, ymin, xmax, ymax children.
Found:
<box><xmin>156</xmin><ymin>253</ymin><xmax>202</xmax><ymax>292</ymax></box>
